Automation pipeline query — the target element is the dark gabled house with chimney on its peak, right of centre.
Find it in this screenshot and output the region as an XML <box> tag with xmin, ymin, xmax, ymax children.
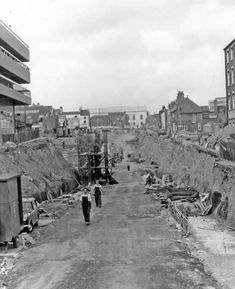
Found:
<box><xmin>168</xmin><ymin>91</ymin><xmax>202</xmax><ymax>133</ymax></box>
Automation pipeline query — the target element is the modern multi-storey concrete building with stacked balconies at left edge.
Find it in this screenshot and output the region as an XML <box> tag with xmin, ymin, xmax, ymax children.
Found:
<box><xmin>0</xmin><ymin>20</ymin><xmax>31</xmax><ymax>141</ymax></box>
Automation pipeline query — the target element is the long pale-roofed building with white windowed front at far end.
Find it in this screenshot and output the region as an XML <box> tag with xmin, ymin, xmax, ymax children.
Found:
<box><xmin>90</xmin><ymin>106</ymin><xmax>148</xmax><ymax>128</ymax></box>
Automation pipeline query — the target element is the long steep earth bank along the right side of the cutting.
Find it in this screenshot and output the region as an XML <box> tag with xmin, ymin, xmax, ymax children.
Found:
<box><xmin>135</xmin><ymin>132</ymin><xmax>235</xmax><ymax>228</ymax></box>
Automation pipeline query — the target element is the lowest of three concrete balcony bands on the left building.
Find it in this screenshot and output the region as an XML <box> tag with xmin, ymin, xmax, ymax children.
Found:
<box><xmin>0</xmin><ymin>76</ymin><xmax>31</xmax><ymax>105</ymax></box>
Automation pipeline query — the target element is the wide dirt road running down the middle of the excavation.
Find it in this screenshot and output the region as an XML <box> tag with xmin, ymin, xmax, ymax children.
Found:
<box><xmin>9</xmin><ymin>160</ymin><xmax>220</xmax><ymax>289</ymax></box>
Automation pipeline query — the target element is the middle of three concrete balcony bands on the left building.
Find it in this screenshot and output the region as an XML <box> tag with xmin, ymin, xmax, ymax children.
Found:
<box><xmin>0</xmin><ymin>46</ymin><xmax>30</xmax><ymax>83</ymax></box>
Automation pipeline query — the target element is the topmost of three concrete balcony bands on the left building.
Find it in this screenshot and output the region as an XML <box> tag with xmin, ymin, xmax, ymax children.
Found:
<box><xmin>0</xmin><ymin>20</ymin><xmax>29</xmax><ymax>62</ymax></box>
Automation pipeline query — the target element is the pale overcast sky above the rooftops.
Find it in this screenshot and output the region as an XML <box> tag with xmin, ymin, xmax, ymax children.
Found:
<box><xmin>0</xmin><ymin>0</ymin><xmax>235</xmax><ymax>112</ymax></box>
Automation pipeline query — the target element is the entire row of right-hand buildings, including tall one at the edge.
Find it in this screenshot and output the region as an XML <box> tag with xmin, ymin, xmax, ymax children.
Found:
<box><xmin>158</xmin><ymin>39</ymin><xmax>235</xmax><ymax>133</ymax></box>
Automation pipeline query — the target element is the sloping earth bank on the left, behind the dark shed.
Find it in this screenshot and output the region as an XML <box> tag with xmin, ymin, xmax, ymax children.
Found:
<box><xmin>0</xmin><ymin>138</ymin><xmax>77</xmax><ymax>202</ymax></box>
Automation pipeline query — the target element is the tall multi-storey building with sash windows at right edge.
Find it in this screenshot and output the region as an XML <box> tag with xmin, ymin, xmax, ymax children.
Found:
<box><xmin>224</xmin><ymin>39</ymin><xmax>235</xmax><ymax>124</ymax></box>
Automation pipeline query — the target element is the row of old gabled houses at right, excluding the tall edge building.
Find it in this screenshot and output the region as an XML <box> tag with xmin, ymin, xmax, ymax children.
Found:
<box><xmin>159</xmin><ymin>91</ymin><xmax>227</xmax><ymax>134</ymax></box>
